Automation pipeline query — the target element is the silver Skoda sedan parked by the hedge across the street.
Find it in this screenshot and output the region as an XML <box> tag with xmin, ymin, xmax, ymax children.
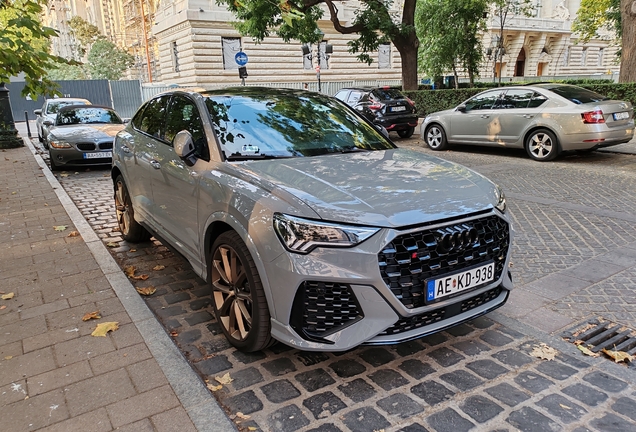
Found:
<box><xmin>421</xmin><ymin>83</ymin><xmax>634</xmax><ymax>161</ymax></box>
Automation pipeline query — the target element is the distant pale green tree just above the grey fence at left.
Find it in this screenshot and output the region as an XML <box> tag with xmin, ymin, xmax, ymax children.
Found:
<box><xmin>88</xmin><ymin>39</ymin><xmax>135</xmax><ymax>80</ymax></box>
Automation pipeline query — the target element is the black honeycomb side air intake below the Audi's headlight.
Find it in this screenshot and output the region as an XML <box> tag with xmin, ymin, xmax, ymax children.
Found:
<box><xmin>290</xmin><ymin>281</ymin><xmax>364</xmax><ymax>342</ymax></box>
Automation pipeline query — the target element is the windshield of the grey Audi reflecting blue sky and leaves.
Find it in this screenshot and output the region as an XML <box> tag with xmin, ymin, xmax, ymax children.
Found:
<box><xmin>205</xmin><ymin>90</ymin><xmax>395</xmax><ymax>160</ymax></box>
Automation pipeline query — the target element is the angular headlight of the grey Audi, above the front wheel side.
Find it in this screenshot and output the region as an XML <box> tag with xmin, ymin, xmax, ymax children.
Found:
<box><xmin>274</xmin><ymin>213</ymin><xmax>380</xmax><ymax>253</ymax></box>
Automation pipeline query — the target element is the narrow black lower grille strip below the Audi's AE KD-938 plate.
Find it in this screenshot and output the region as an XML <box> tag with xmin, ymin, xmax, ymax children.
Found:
<box><xmin>379</xmin><ymin>287</ymin><xmax>502</xmax><ymax>336</ymax></box>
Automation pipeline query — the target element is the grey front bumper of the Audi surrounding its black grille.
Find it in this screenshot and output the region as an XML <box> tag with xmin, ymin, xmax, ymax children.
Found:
<box><xmin>266</xmin><ymin>211</ymin><xmax>513</xmax><ymax>351</ymax></box>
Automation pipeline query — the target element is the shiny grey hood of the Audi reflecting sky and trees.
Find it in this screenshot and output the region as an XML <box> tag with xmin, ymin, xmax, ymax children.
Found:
<box><xmin>237</xmin><ymin>149</ymin><xmax>497</xmax><ymax>227</ymax></box>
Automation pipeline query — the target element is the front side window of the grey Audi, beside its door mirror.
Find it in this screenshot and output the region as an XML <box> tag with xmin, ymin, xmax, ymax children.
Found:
<box><xmin>165</xmin><ymin>96</ymin><xmax>210</xmax><ymax>160</ymax></box>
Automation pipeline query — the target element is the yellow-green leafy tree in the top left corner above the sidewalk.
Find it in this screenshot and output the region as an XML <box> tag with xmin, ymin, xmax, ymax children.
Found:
<box><xmin>0</xmin><ymin>0</ymin><xmax>72</xmax><ymax>99</ymax></box>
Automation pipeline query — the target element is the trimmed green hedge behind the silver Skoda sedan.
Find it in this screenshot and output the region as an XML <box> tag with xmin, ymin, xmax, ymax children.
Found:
<box><xmin>404</xmin><ymin>82</ymin><xmax>636</xmax><ymax>117</ymax></box>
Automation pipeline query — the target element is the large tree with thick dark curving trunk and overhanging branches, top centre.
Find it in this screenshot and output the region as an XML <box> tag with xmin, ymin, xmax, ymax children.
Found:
<box><xmin>217</xmin><ymin>0</ymin><xmax>419</xmax><ymax>90</ymax></box>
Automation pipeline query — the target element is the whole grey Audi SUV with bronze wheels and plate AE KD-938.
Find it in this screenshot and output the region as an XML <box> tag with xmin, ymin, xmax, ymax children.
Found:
<box><xmin>112</xmin><ymin>87</ymin><xmax>512</xmax><ymax>351</ymax></box>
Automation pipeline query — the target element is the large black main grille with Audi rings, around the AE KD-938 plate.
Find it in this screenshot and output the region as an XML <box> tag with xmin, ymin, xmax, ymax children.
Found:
<box><xmin>378</xmin><ymin>215</ymin><xmax>510</xmax><ymax>309</ymax></box>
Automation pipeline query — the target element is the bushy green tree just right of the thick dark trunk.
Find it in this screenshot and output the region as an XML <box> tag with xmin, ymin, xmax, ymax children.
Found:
<box><xmin>415</xmin><ymin>0</ymin><xmax>488</xmax><ymax>88</ymax></box>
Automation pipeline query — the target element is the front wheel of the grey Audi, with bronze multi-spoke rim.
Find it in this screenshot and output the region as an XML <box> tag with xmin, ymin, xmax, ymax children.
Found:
<box><xmin>208</xmin><ymin>231</ymin><xmax>274</xmax><ymax>352</ymax></box>
